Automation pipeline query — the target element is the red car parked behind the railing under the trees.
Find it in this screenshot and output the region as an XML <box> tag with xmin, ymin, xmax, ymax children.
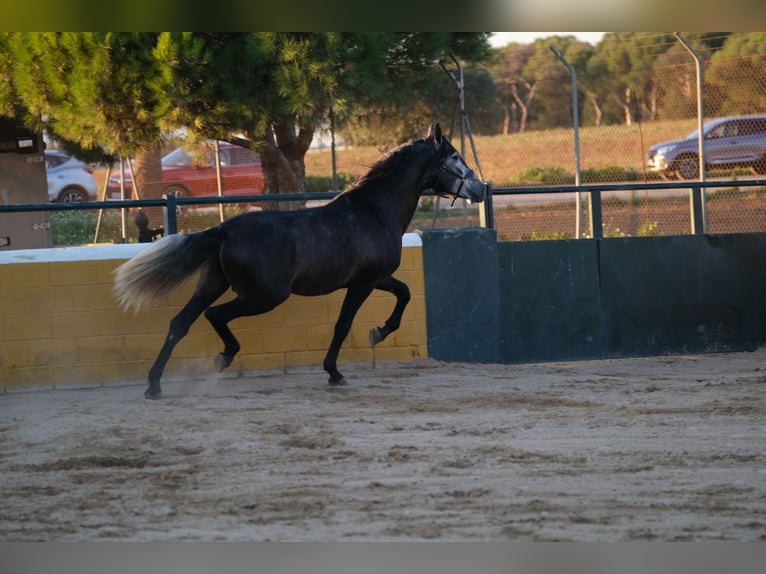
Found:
<box><xmin>107</xmin><ymin>142</ymin><xmax>264</xmax><ymax>199</ymax></box>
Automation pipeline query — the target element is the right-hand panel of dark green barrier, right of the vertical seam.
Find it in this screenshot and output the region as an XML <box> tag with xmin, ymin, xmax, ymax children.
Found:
<box><xmin>601</xmin><ymin>234</ymin><xmax>766</xmax><ymax>356</ymax></box>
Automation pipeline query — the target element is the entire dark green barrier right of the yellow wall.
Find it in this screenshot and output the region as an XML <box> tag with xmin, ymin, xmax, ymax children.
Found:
<box><xmin>423</xmin><ymin>230</ymin><xmax>766</xmax><ymax>363</ymax></box>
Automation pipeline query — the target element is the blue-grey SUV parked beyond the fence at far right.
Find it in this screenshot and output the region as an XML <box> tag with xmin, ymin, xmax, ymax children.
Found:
<box><xmin>647</xmin><ymin>115</ymin><xmax>766</xmax><ymax>179</ymax></box>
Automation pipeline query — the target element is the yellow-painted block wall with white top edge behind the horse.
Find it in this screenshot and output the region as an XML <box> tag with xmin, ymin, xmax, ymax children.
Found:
<box><xmin>0</xmin><ymin>234</ymin><xmax>428</xmax><ymax>390</ymax></box>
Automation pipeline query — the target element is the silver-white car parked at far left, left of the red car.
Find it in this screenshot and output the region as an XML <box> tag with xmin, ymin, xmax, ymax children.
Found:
<box><xmin>44</xmin><ymin>150</ymin><xmax>98</xmax><ymax>202</ymax></box>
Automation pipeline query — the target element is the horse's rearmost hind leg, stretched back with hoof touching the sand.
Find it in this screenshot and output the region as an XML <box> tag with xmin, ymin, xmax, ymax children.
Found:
<box><xmin>144</xmin><ymin>270</ymin><xmax>229</xmax><ymax>399</ymax></box>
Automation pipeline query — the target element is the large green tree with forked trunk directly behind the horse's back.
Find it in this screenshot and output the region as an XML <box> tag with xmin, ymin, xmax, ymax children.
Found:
<box><xmin>155</xmin><ymin>32</ymin><xmax>488</xmax><ymax>207</ymax></box>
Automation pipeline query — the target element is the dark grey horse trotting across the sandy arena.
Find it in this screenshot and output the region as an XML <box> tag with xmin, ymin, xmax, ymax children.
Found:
<box><xmin>114</xmin><ymin>124</ymin><xmax>488</xmax><ymax>399</ymax></box>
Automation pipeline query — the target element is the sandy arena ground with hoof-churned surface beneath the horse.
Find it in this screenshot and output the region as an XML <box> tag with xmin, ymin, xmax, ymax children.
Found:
<box><xmin>0</xmin><ymin>349</ymin><xmax>766</xmax><ymax>541</ymax></box>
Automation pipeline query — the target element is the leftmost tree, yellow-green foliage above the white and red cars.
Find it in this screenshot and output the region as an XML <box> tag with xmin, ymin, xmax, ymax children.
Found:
<box><xmin>6</xmin><ymin>32</ymin><xmax>162</xmax><ymax>217</ymax></box>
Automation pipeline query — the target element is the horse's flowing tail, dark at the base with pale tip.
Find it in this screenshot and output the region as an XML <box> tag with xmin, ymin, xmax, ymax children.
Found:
<box><xmin>114</xmin><ymin>228</ymin><xmax>223</xmax><ymax>312</ymax></box>
